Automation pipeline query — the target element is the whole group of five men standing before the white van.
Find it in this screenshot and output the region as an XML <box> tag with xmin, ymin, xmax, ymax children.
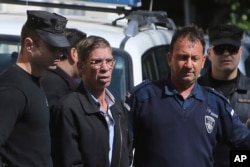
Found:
<box><xmin>0</xmin><ymin>10</ymin><xmax>250</xmax><ymax>167</ymax></box>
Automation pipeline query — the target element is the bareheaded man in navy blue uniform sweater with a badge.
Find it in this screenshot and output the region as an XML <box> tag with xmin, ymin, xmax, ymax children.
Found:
<box><xmin>126</xmin><ymin>25</ymin><xmax>250</xmax><ymax>167</ymax></box>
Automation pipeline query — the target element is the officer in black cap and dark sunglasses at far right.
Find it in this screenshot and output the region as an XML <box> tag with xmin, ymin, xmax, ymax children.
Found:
<box><xmin>198</xmin><ymin>24</ymin><xmax>250</xmax><ymax>167</ymax></box>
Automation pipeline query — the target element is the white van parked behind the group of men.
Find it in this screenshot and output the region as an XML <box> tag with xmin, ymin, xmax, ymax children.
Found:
<box><xmin>0</xmin><ymin>1</ymin><xmax>175</xmax><ymax>100</ymax></box>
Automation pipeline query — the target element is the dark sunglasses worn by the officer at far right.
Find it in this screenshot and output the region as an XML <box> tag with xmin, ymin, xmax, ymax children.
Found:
<box><xmin>213</xmin><ymin>44</ymin><xmax>240</xmax><ymax>55</ymax></box>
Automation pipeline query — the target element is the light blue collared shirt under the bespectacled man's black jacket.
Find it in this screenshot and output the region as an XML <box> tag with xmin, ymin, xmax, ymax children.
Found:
<box><xmin>91</xmin><ymin>89</ymin><xmax>115</xmax><ymax>164</ymax></box>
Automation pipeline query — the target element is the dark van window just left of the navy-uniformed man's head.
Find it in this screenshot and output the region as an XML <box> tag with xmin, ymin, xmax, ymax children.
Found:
<box><xmin>142</xmin><ymin>45</ymin><xmax>169</xmax><ymax>80</ymax></box>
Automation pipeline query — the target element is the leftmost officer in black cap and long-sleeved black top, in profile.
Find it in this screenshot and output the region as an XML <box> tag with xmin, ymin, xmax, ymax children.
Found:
<box><xmin>0</xmin><ymin>10</ymin><xmax>69</xmax><ymax>167</ymax></box>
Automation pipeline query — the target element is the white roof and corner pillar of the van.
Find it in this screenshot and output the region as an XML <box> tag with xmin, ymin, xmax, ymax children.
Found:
<box><xmin>0</xmin><ymin>10</ymin><xmax>174</xmax><ymax>84</ymax></box>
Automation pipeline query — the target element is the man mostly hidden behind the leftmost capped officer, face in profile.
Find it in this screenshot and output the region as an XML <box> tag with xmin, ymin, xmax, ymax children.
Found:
<box><xmin>40</xmin><ymin>28</ymin><xmax>87</xmax><ymax>108</ymax></box>
